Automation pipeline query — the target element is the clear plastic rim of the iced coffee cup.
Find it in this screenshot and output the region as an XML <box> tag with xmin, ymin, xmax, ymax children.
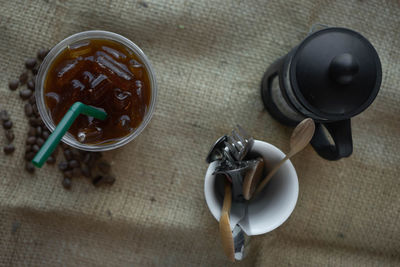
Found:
<box><xmin>35</xmin><ymin>30</ymin><xmax>157</xmax><ymax>151</ymax></box>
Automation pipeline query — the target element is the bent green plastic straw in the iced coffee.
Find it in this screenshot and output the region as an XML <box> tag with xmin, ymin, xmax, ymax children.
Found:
<box><xmin>32</xmin><ymin>102</ymin><xmax>107</xmax><ymax>168</ymax></box>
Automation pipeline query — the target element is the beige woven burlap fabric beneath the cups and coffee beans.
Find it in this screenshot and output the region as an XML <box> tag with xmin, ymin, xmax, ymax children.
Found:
<box><xmin>0</xmin><ymin>0</ymin><xmax>400</xmax><ymax>266</ymax></box>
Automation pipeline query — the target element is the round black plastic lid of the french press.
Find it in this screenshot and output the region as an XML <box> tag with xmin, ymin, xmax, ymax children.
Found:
<box><xmin>290</xmin><ymin>28</ymin><xmax>382</xmax><ymax>120</ymax></box>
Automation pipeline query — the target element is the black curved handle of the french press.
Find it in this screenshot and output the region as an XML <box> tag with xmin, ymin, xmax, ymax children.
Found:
<box><xmin>311</xmin><ymin>119</ymin><xmax>353</xmax><ymax>160</ymax></box>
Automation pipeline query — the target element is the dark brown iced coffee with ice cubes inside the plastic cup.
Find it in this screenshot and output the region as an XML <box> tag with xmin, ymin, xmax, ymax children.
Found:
<box><xmin>44</xmin><ymin>40</ymin><xmax>151</xmax><ymax>144</ymax></box>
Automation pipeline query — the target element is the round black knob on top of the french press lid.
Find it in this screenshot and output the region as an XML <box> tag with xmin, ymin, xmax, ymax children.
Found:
<box><xmin>329</xmin><ymin>53</ymin><xmax>358</xmax><ymax>85</ymax></box>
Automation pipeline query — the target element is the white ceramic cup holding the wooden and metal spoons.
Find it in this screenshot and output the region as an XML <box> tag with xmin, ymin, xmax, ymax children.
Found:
<box><xmin>204</xmin><ymin>140</ymin><xmax>299</xmax><ymax>236</ymax></box>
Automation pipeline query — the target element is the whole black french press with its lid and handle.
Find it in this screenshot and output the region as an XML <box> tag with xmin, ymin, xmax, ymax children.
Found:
<box><xmin>261</xmin><ymin>27</ymin><xmax>382</xmax><ymax>160</ymax></box>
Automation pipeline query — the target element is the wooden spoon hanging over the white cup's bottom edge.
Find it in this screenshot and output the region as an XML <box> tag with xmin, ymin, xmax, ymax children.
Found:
<box><xmin>219</xmin><ymin>180</ymin><xmax>235</xmax><ymax>262</ymax></box>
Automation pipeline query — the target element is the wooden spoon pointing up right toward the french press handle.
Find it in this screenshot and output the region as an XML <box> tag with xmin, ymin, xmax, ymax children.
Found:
<box><xmin>254</xmin><ymin>118</ymin><xmax>315</xmax><ymax>195</ymax></box>
